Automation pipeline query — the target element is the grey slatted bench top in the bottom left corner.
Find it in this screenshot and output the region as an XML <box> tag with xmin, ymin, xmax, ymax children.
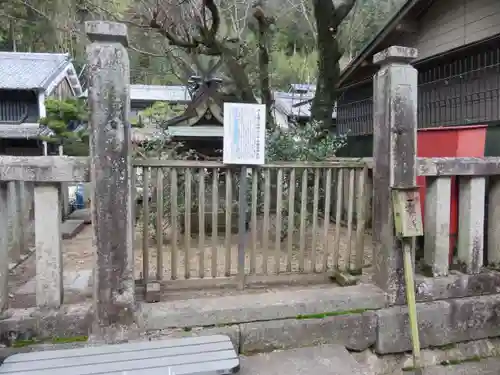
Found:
<box><xmin>0</xmin><ymin>335</ymin><xmax>240</xmax><ymax>375</ymax></box>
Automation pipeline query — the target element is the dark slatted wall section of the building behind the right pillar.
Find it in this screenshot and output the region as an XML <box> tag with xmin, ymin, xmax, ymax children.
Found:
<box><xmin>337</xmin><ymin>40</ymin><xmax>500</xmax><ymax>136</ymax></box>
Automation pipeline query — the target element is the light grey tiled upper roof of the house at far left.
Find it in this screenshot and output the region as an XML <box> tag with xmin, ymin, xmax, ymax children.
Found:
<box><xmin>0</xmin><ymin>52</ymin><xmax>71</xmax><ymax>90</ymax></box>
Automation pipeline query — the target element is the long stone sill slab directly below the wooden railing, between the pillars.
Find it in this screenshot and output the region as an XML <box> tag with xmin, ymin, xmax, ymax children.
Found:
<box><xmin>138</xmin><ymin>285</ymin><xmax>385</xmax><ymax>330</ymax></box>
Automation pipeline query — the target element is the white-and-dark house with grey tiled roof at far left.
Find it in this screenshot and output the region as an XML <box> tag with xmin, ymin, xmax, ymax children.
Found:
<box><xmin>0</xmin><ymin>52</ymin><xmax>82</xmax><ymax>156</ymax></box>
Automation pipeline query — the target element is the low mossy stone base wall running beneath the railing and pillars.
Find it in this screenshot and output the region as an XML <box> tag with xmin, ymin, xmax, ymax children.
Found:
<box><xmin>0</xmin><ymin>285</ymin><xmax>500</xmax><ymax>355</ymax></box>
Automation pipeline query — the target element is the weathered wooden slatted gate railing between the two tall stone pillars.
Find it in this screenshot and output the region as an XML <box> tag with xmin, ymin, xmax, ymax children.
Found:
<box><xmin>134</xmin><ymin>160</ymin><xmax>371</xmax><ymax>288</ymax></box>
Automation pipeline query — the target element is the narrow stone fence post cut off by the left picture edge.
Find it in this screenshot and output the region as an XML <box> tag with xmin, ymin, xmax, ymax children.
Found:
<box><xmin>0</xmin><ymin>181</ymin><xmax>9</xmax><ymax>319</ymax></box>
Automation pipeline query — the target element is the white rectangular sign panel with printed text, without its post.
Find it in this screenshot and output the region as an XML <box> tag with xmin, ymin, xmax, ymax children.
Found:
<box><xmin>223</xmin><ymin>103</ymin><xmax>266</xmax><ymax>165</ymax></box>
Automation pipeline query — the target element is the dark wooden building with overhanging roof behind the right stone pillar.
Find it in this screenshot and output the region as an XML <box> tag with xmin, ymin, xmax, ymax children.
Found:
<box><xmin>337</xmin><ymin>0</ymin><xmax>500</xmax><ymax>156</ymax></box>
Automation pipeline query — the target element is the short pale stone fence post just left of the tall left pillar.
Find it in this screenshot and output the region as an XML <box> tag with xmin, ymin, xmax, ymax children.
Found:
<box><xmin>35</xmin><ymin>184</ymin><xmax>63</xmax><ymax>309</ymax></box>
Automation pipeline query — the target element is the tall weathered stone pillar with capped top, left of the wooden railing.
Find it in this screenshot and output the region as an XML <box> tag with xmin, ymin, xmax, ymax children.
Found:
<box><xmin>85</xmin><ymin>21</ymin><xmax>135</xmax><ymax>335</ymax></box>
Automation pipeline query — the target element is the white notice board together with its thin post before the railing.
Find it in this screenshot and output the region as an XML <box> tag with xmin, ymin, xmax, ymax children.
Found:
<box><xmin>223</xmin><ymin>103</ymin><xmax>266</xmax><ymax>289</ymax></box>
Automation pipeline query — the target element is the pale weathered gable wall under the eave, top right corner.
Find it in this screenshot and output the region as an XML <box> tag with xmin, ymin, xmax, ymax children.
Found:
<box><xmin>412</xmin><ymin>0</ymin><xmax>500</xmax><ymax>58</ymax></box>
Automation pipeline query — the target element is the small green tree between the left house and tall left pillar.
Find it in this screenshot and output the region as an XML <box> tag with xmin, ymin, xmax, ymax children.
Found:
<box><xmin>40</xmin><ymin>98</ymin><xmax>89</xmax><ymax>156</ymax></box>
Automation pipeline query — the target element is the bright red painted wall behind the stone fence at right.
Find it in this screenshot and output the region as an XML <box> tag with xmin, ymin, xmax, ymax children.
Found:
<box><xmin>417</xmin><ymin>125</ymin><xmax>487</xmax><ymax>261</ymax></box>
